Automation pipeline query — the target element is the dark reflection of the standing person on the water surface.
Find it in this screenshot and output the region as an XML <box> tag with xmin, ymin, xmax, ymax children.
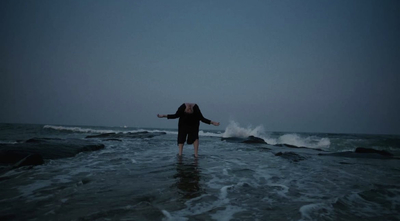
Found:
<box><xmin>174</xmin><ymin>157</ymin><xmax>203</xmax><ymax>199</ymax></box>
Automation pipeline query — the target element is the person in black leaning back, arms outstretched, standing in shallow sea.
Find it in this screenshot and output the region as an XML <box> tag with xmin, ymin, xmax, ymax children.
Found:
<box><xmin>157</xmin><ymin>103</ymin><xmax>219</xmax><ymax>157</ymax></box>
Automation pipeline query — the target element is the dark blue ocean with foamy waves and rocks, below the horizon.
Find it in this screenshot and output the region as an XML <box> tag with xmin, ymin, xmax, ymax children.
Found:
<box><xmin>0</xmin><ymin>122</ymin><xmax>400</xmax><ymax>221</ymax></box>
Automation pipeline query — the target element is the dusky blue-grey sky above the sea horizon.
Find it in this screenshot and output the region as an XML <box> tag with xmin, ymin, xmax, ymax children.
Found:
<box><xmin>0</xmin><ymin>0</ymin><xmax>400</xmax><ymax>134</ymax></box>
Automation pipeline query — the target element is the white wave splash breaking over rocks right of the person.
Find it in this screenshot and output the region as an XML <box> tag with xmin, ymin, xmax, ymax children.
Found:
<box><xmin>222</xmin><ymin>121</ymin><xmax>331</xmax><ymax>148</ymax></box>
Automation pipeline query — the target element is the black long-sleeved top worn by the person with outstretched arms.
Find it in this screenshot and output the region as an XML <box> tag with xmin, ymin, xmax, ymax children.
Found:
<box><xmin>167</xmin><ymin>104</ymin><xmax>211</xmax><ymax>128</ymax></box>
